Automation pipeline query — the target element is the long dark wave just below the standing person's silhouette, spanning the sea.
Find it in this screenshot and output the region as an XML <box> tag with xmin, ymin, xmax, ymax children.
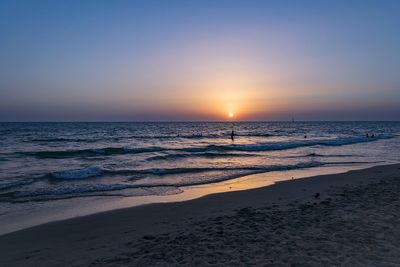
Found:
<box><xmin>19</xmin><ymin>135</ymin><xmax>391</xmax><ymax>158</ymax></box>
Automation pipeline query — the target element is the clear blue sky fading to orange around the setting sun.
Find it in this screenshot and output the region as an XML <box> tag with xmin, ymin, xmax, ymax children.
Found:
<box><xmin>0</xmin><ymin>0</ymin><xmax>400</xmax><ymax>121</ymax></box>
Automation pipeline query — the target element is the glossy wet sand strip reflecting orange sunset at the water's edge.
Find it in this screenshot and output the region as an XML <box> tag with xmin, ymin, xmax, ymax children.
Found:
<box><xmin>0</xmin><ymin>160</ymin><xmax>382</xmax><ymax>236</ymax></box>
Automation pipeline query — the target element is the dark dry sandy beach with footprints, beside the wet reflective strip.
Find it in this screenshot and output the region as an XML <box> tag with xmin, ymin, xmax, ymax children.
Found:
<box><xmin>0</xmin><ymin>164</ymin><xmax>400</xmax><ymax>266</ymax></box>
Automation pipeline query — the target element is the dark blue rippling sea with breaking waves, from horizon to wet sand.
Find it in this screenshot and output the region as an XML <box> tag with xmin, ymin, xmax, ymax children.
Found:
<box><xmin>0</xmin><ymin>122</ymin><xmax>400</xmax><ymax>205</ymax></box>
